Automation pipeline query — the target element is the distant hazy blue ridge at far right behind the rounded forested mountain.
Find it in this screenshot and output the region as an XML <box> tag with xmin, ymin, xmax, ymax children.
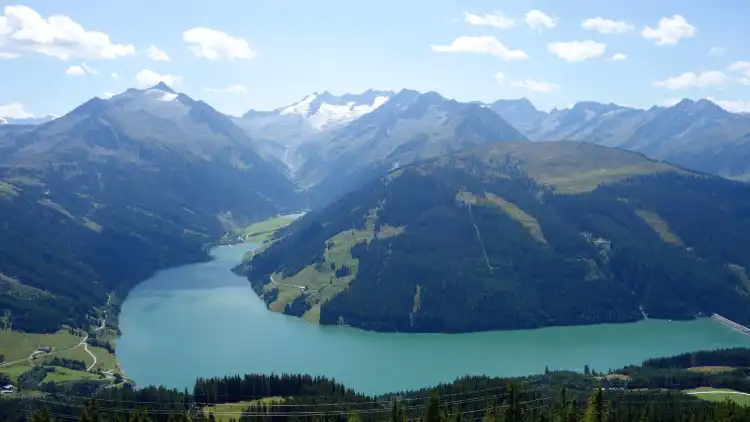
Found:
<box><xmin>491</xmin><ymin>99</ymin><xmax>750</xmax><ymax>179</ymax></box>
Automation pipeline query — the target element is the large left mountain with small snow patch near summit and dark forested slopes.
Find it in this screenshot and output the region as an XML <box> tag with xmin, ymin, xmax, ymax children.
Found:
<box><xmin>0</xmin><ymin>84</ymin><xmax>299</xmax><ymax>331</ymax></box>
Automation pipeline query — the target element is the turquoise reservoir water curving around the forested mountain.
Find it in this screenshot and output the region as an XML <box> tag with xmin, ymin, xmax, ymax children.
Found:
<box><xmin>117</xmin><ymin>244</ymin><xmax>750</xmax><ymax>394</ymax></box>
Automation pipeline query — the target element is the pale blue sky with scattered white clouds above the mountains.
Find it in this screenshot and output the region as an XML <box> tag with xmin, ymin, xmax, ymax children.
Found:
<box><xmin>0</xmin><ymin>0</ymin><xmax>750</xmax><ymax>117</ymax></box>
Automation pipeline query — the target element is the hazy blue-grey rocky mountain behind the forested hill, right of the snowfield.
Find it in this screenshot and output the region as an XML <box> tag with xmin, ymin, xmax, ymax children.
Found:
<box><xmin>294</xmin><ymin>90</ymin><xmax>526</xmax><ymax>205</ymax></box>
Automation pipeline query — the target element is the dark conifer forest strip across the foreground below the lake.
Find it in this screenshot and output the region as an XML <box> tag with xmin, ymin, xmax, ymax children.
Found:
<box><xmin>7</xmin><ymin>349</ymin><xmax>750</xmax><ymax>422</ymax></box>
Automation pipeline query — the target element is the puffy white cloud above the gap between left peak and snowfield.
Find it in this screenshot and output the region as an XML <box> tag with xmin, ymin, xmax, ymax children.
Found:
<box><xmin>182</xmin><ymin>27</ymin><xmax>256</xmax><ymax>60</ymax></box>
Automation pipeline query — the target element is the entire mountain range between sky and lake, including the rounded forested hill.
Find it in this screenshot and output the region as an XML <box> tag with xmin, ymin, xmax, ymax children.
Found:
<box><xmin>0</xmin><ymin>83</ymin><xmax>750</xmax><ymax>332</ymax></box>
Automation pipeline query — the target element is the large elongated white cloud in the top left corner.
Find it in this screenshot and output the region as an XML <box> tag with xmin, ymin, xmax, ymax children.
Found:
<box><xmin>0</xmin><ymin>6</ymin><xmax>135</xmax><ymax>60</ymax></box>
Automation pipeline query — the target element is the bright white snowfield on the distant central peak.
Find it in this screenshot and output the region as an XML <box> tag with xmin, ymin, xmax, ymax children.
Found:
<box><xmin>278</xmin><ymin>90</ymin><xmax>393</xmax><ymax>130</ymax></box>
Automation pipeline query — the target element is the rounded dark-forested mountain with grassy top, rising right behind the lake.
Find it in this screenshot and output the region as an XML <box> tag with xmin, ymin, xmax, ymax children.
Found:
<box><xmin>245</xmin><ymin>142</ymin><xmax>750</xmax><ymax>332</ymax></box>
